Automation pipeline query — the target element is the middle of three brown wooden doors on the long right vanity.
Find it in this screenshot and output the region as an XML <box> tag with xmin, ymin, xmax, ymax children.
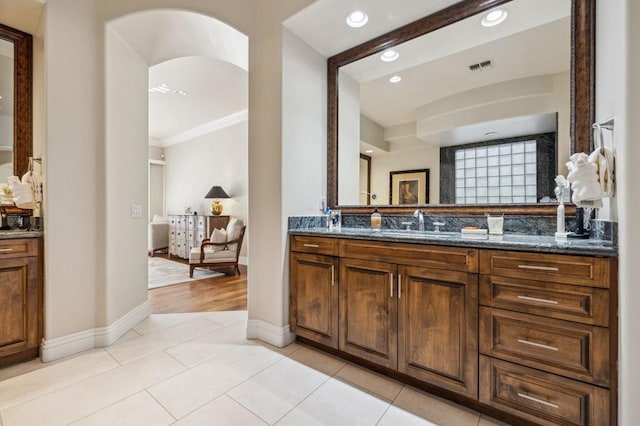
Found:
<box><xmin>340</xmin><ymin>259</ymin><xmax>398</xmax><ymax>369</ymax></box>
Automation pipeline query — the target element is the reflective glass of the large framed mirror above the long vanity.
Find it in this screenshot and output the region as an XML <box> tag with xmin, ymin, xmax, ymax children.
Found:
<box><xmin>338</xmin><ymin>0</ymin><xmax>571</xmax><ymax>205</ymax></box>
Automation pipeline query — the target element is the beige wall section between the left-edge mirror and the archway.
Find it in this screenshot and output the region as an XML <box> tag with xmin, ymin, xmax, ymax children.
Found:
<box><xmin>44</xmin><ymin>0</ymin><xmax>102</xmax><ymax>339</ymax></box>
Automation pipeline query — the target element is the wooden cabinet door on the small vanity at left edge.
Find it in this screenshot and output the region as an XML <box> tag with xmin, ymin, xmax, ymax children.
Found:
<box><xmin>0</xmin><ymin>257</ymin><xmax>40</xmax><ymax>358</ymax></box>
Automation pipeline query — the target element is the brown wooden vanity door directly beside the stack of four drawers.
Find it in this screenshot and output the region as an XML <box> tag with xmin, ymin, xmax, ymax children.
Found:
<box><xmin>398</xmin><ymin>266</ymin><xmax>478</xmax><ymax>398</ymax></box>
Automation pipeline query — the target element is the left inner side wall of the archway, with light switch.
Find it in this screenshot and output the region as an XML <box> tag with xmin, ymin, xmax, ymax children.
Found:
<box><xmin>105</xmin><ymin>27</ymin><xmax>149</xmax><ymax>324</ymax></box>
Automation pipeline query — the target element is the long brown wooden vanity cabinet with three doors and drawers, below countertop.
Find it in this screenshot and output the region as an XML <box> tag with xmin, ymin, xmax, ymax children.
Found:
<box><xmin>290</xmin><ymin>235</ymin><xmax>617</xmax><ymax>426</ymax></box>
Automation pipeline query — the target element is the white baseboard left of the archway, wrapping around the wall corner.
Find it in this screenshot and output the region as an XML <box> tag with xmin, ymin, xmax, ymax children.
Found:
<box><xmin>40</xmin><ymin>300</ymin><xmax>151</xmax><ymax>362</ymax></box>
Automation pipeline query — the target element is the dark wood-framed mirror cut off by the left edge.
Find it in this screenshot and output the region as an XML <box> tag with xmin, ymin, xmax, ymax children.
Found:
<box><xmin>0</xmin><ymin>25</ymin><xmax>33</xmax><ymax>183</ymax></box>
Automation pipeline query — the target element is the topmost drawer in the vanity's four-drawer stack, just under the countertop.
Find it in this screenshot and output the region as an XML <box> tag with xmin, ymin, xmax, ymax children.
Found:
<box><xmin>480</xmin><ymin>250</ymin><xmax>611</xmax><ymax>288</ymax></box>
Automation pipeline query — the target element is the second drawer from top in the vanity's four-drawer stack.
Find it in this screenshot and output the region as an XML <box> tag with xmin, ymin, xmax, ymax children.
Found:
<box><xmin>480</xmin><ymin>275</ymin><xmax>609</xmax><ymax>327</ymax></box>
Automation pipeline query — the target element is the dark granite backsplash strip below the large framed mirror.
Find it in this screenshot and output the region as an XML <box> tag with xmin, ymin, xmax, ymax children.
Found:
<box><xmin>289</xmin><ymin>214</ymin><xmax>617</xmax><ymax>244</ymax></box>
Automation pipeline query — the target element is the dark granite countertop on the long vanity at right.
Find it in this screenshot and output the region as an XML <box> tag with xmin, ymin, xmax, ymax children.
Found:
<box><xmin>289</xmin><ymin>228</ymin><xmax>618</xmax><ymax>257</ymax></box>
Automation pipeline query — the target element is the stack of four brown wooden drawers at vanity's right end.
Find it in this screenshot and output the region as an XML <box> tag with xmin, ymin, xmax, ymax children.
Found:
<box><xmin>479</xmin><ymin>250</ymin><xmax>617</xmax><ymax>425</ymax></box>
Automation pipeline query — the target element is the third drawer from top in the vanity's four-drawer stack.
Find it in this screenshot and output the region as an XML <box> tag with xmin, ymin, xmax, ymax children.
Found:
<box><xmin>480</xmin><ymin>307</ymin><xmax>609</xmax><ymax>386</ymax></box>
